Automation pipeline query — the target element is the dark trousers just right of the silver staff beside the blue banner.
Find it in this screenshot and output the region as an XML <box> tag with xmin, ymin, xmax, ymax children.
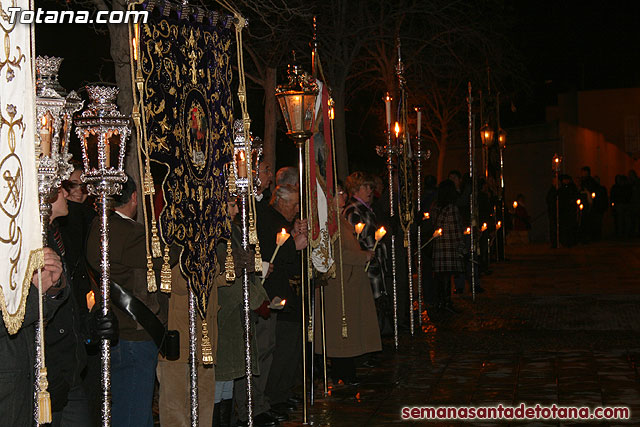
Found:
<box><xmin>233</xmin><ymin>311</ymin><xmax>277</xmax><ymax>421</ymax></box>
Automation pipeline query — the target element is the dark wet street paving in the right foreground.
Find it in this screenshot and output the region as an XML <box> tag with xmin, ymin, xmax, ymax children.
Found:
<box><xmin>284</xmin><ymin>242</ymin><xmax>640</xmax><ymax>426</ymax></box>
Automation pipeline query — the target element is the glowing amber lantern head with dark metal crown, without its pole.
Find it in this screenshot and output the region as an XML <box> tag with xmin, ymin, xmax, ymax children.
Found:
<box><xmin>276</xmin><ymin>63</ymin><xmax>318</xmax><ymax>140</ymax></box>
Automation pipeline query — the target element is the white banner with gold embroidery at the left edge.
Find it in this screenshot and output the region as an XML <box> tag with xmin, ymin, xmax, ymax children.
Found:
<box><xmin>0</xmin><ymin>0</ymin><xmax>43</xmax><ymax>334</ymax></box>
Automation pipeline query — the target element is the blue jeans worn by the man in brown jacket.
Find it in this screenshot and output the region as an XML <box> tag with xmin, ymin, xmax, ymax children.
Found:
<box><xmin>111</xmin><ymin>339</ymin><xmax>158</xmax><ymax>427</ymax></box>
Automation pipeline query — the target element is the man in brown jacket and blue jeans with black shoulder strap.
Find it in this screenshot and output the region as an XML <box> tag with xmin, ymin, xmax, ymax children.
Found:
<box><xmin>87</xmin><ymin>177</ymin><xmax>167</xmax><ymax>427</ymax></box>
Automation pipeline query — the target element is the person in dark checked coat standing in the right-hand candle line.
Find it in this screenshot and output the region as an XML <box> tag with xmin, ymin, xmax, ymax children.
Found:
<box><xmin>433</xmin><ymin>179</ymin><xmax>465</xmax><ymax>313</ymax></box>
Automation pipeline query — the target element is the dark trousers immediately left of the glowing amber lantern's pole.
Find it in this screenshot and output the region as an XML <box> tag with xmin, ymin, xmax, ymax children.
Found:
<box><xmin>265</xmin><ymin>320</ymin><xmax>302</xmax><ymax>405</ymax></box>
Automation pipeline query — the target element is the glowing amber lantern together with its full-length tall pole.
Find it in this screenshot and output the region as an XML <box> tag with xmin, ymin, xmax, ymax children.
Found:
<box><xmin>276</xmin><ymin>63</ymin><xmax>318</xmax><ymax>424</ymax></box>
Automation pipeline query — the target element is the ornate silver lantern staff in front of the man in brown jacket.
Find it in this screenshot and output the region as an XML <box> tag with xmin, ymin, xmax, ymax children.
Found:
<box><xmin>75</xmin><ymin>86</ymin><xmax>130</xmax><ymax>427</ymax></box>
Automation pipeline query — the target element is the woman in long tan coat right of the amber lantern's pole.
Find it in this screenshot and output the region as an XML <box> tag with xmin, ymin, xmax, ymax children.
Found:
<box><xmin>315</xmin><ymin>183</ymin><xmax>382</xmax><ymax>384</ymax></box>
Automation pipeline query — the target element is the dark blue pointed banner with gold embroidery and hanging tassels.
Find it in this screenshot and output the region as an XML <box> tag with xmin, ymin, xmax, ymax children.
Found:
<box><xmin>140</xmin><ymin>14</ymin><xmax>233</xmax><ymax>318</ymax></box>
